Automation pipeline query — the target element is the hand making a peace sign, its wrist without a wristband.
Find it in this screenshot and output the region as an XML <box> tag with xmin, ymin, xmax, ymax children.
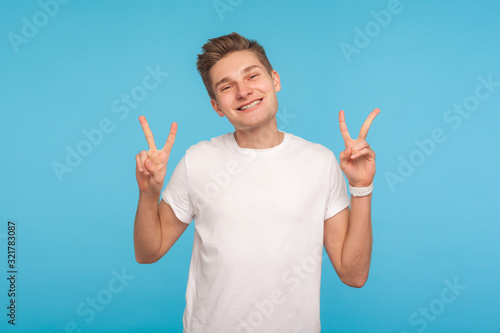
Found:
<box><xmin>135</xmin><ymin>116</ymin><xmax>177</xmax><ymax>195</ymax></box>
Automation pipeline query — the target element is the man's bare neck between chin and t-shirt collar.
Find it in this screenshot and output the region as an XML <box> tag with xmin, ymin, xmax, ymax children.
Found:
<box><xmin>234</xmin><ymin>126</ymin><xmax>285</xmax><ymax>149</ymax></box>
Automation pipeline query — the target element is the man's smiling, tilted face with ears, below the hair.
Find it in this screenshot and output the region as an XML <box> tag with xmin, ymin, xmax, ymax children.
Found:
<box><xmin>210</xmin><ymin>51</ymin><xmax>281</xmax><ymax>130</ymax></box>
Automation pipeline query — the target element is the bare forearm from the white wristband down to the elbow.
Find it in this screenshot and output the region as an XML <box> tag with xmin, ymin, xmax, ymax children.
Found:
<box><xmin>341</xmin><ymin>194</ymin><xmax>373</xmax><ymax>285</ymax></box>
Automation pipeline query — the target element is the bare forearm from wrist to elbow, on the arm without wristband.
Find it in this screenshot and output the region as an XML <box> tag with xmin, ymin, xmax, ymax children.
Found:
<box><xmin>134</xmin><ymin>192</ymin><xmax>161</xmax><ymax>263</ymax></box>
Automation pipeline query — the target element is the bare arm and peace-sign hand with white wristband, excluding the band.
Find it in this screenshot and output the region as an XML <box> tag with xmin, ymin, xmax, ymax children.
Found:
<box><xmin>323</xmin><ymin>109</ymin><xmax>380</xmax><ymax>288</ymax></box>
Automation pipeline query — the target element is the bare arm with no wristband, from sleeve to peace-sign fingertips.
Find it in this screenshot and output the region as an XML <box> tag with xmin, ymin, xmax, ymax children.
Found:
<box><xmin>134</xmin><ymin>116</ymin><xmax>188</xmax><ymax>264</ymax></box>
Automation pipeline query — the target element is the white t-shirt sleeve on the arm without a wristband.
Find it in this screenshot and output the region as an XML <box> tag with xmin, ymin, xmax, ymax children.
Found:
<box><xmin>162</xmin><ymin>155</ymin><xmax>194</xmax><ymax>224</ymax></box>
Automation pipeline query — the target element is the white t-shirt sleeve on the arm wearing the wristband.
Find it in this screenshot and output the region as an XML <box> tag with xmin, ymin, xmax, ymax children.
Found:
<box><xmin>325</xmin><ymin>153</ymin><xmax>350</xmax><ymax>220</ymax></box>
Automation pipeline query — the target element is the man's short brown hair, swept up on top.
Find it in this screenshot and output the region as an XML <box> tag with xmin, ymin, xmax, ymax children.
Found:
<box><xmin>196</xmin><ymin>32</ymin><xmax>273</xmax><ymax>99</ymax></box>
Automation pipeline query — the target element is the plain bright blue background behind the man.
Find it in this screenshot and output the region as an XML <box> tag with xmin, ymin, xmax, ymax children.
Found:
<box><xmin>0</xmin><ymin>0</ymin><xmax>500</xmax><ymax>333</ymax></box>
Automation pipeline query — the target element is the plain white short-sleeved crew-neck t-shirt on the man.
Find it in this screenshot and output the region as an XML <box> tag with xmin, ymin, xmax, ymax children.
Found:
<box><xmin>162</xmin><ymin>132</ymin><xmax>349</xmax><ymax>333</ymax></box>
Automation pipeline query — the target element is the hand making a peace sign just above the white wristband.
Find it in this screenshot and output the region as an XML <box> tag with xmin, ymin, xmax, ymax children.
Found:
<box><xmin>339</xmin><ymin>109</ymin><xmax>380</xmax><ymax>187</ymax></box>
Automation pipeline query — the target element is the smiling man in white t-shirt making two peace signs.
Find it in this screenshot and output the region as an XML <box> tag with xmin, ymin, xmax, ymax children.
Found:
<box><xmin>134</xmin><ymin>33</ymin><xmax>379</xmax><ymax>333</ymax></box>
